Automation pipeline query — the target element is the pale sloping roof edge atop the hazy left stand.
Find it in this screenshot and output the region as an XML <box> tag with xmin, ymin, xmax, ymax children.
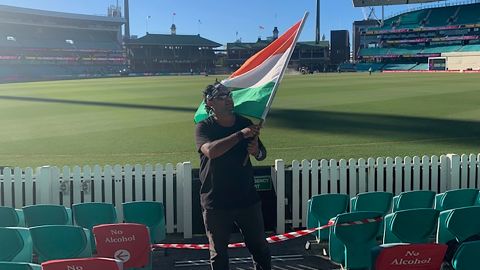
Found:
<box><xmin>0</xmin><ymin>5</ymin><xmax>125</xmax><ymax>24</ymax></box>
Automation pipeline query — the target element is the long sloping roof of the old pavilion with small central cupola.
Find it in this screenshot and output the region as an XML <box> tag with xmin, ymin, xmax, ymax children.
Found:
<box><xmin>128</xmin><ymin>34</ymin><xmax>222</xmax><ymax>47</ymax></box>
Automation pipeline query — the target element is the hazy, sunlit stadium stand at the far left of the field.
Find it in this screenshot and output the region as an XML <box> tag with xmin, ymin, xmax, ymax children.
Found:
<box><xmin>0</xmin><ymin>5</ymin><xmax>126</xmax><ymax>82</ymax></box>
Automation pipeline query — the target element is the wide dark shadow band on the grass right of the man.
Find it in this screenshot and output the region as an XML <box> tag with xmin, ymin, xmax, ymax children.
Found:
<box><xmin>267</xmin><ymin>109</ymin><xmax>480</xmax><ymax>145</ymax></box>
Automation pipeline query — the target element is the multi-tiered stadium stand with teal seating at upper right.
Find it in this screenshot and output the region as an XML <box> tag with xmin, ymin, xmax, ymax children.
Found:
<box><xmin>356</xmin><ymin>2</ymin><xmax>480</xmax><ymax>71</ymax></box>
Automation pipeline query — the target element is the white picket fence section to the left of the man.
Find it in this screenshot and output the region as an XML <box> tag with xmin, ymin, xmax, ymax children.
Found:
<box><xmin>0</xmin><ymin>162</ymin><xmax>192</xmax><ymax>238</ymax></box>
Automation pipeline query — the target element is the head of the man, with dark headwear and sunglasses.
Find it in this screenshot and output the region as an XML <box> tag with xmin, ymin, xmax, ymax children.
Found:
<box><xmin>203</xmin><ymin>81</ymin><xmax>233</xmax><ymax>115</ymax></box>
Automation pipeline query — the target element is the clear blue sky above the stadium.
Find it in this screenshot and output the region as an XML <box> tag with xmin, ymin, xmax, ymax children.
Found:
<box><xmin>0</xmin><ymin>0</ymin><xmax>464</xmax><ymax>44</ymax></box>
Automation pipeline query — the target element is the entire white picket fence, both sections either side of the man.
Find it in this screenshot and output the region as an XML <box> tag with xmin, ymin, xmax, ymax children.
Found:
<box><xmin>0</xmin><ymin>154</ymin><xmax>480</xmax><ymax>238</ymax></box>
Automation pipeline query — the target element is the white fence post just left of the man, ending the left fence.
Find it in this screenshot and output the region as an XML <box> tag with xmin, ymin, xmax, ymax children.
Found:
<box><xmin>182</xmin><ymin>162</ymin><xmax>192</xmax><ymax>238</ymax></box>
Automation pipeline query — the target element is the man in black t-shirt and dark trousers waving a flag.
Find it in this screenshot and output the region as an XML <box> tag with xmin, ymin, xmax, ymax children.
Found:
<box><xmin>195</xmin><ymin>82</ymin><xmax>271</xmax><ymax>270</ymax></box>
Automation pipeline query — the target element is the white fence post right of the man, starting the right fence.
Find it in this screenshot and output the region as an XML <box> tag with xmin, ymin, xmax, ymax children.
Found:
<box><xmin>274</xmin><ymin>159</ymin><xmax>287</xmax><ymax>233</ymax></box>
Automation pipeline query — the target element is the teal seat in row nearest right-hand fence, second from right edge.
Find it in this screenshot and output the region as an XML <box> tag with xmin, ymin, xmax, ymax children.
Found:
<box><xmin>392</xmin><ymin>190</ymin><xmax>435</xmax><ymax>212</ymax></box>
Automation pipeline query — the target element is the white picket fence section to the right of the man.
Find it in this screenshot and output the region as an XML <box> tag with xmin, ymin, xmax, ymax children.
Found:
<box><xmin>272</xmin><ymin>154</ymin><xmax>480</xmax><ymax>233</ymax></box>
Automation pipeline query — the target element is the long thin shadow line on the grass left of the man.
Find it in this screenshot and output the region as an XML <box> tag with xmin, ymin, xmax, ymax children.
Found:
<box><xmin>0</xmin><ymin>96</ymin><xmax>197</xmax><ymax>113</ymax></box>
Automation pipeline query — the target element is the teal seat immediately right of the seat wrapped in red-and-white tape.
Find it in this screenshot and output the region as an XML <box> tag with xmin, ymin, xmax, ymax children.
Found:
<box><xmin>383</xmin><ymin>208</ymin><xmax>439</xmax><ymax>244</ymax></box>
